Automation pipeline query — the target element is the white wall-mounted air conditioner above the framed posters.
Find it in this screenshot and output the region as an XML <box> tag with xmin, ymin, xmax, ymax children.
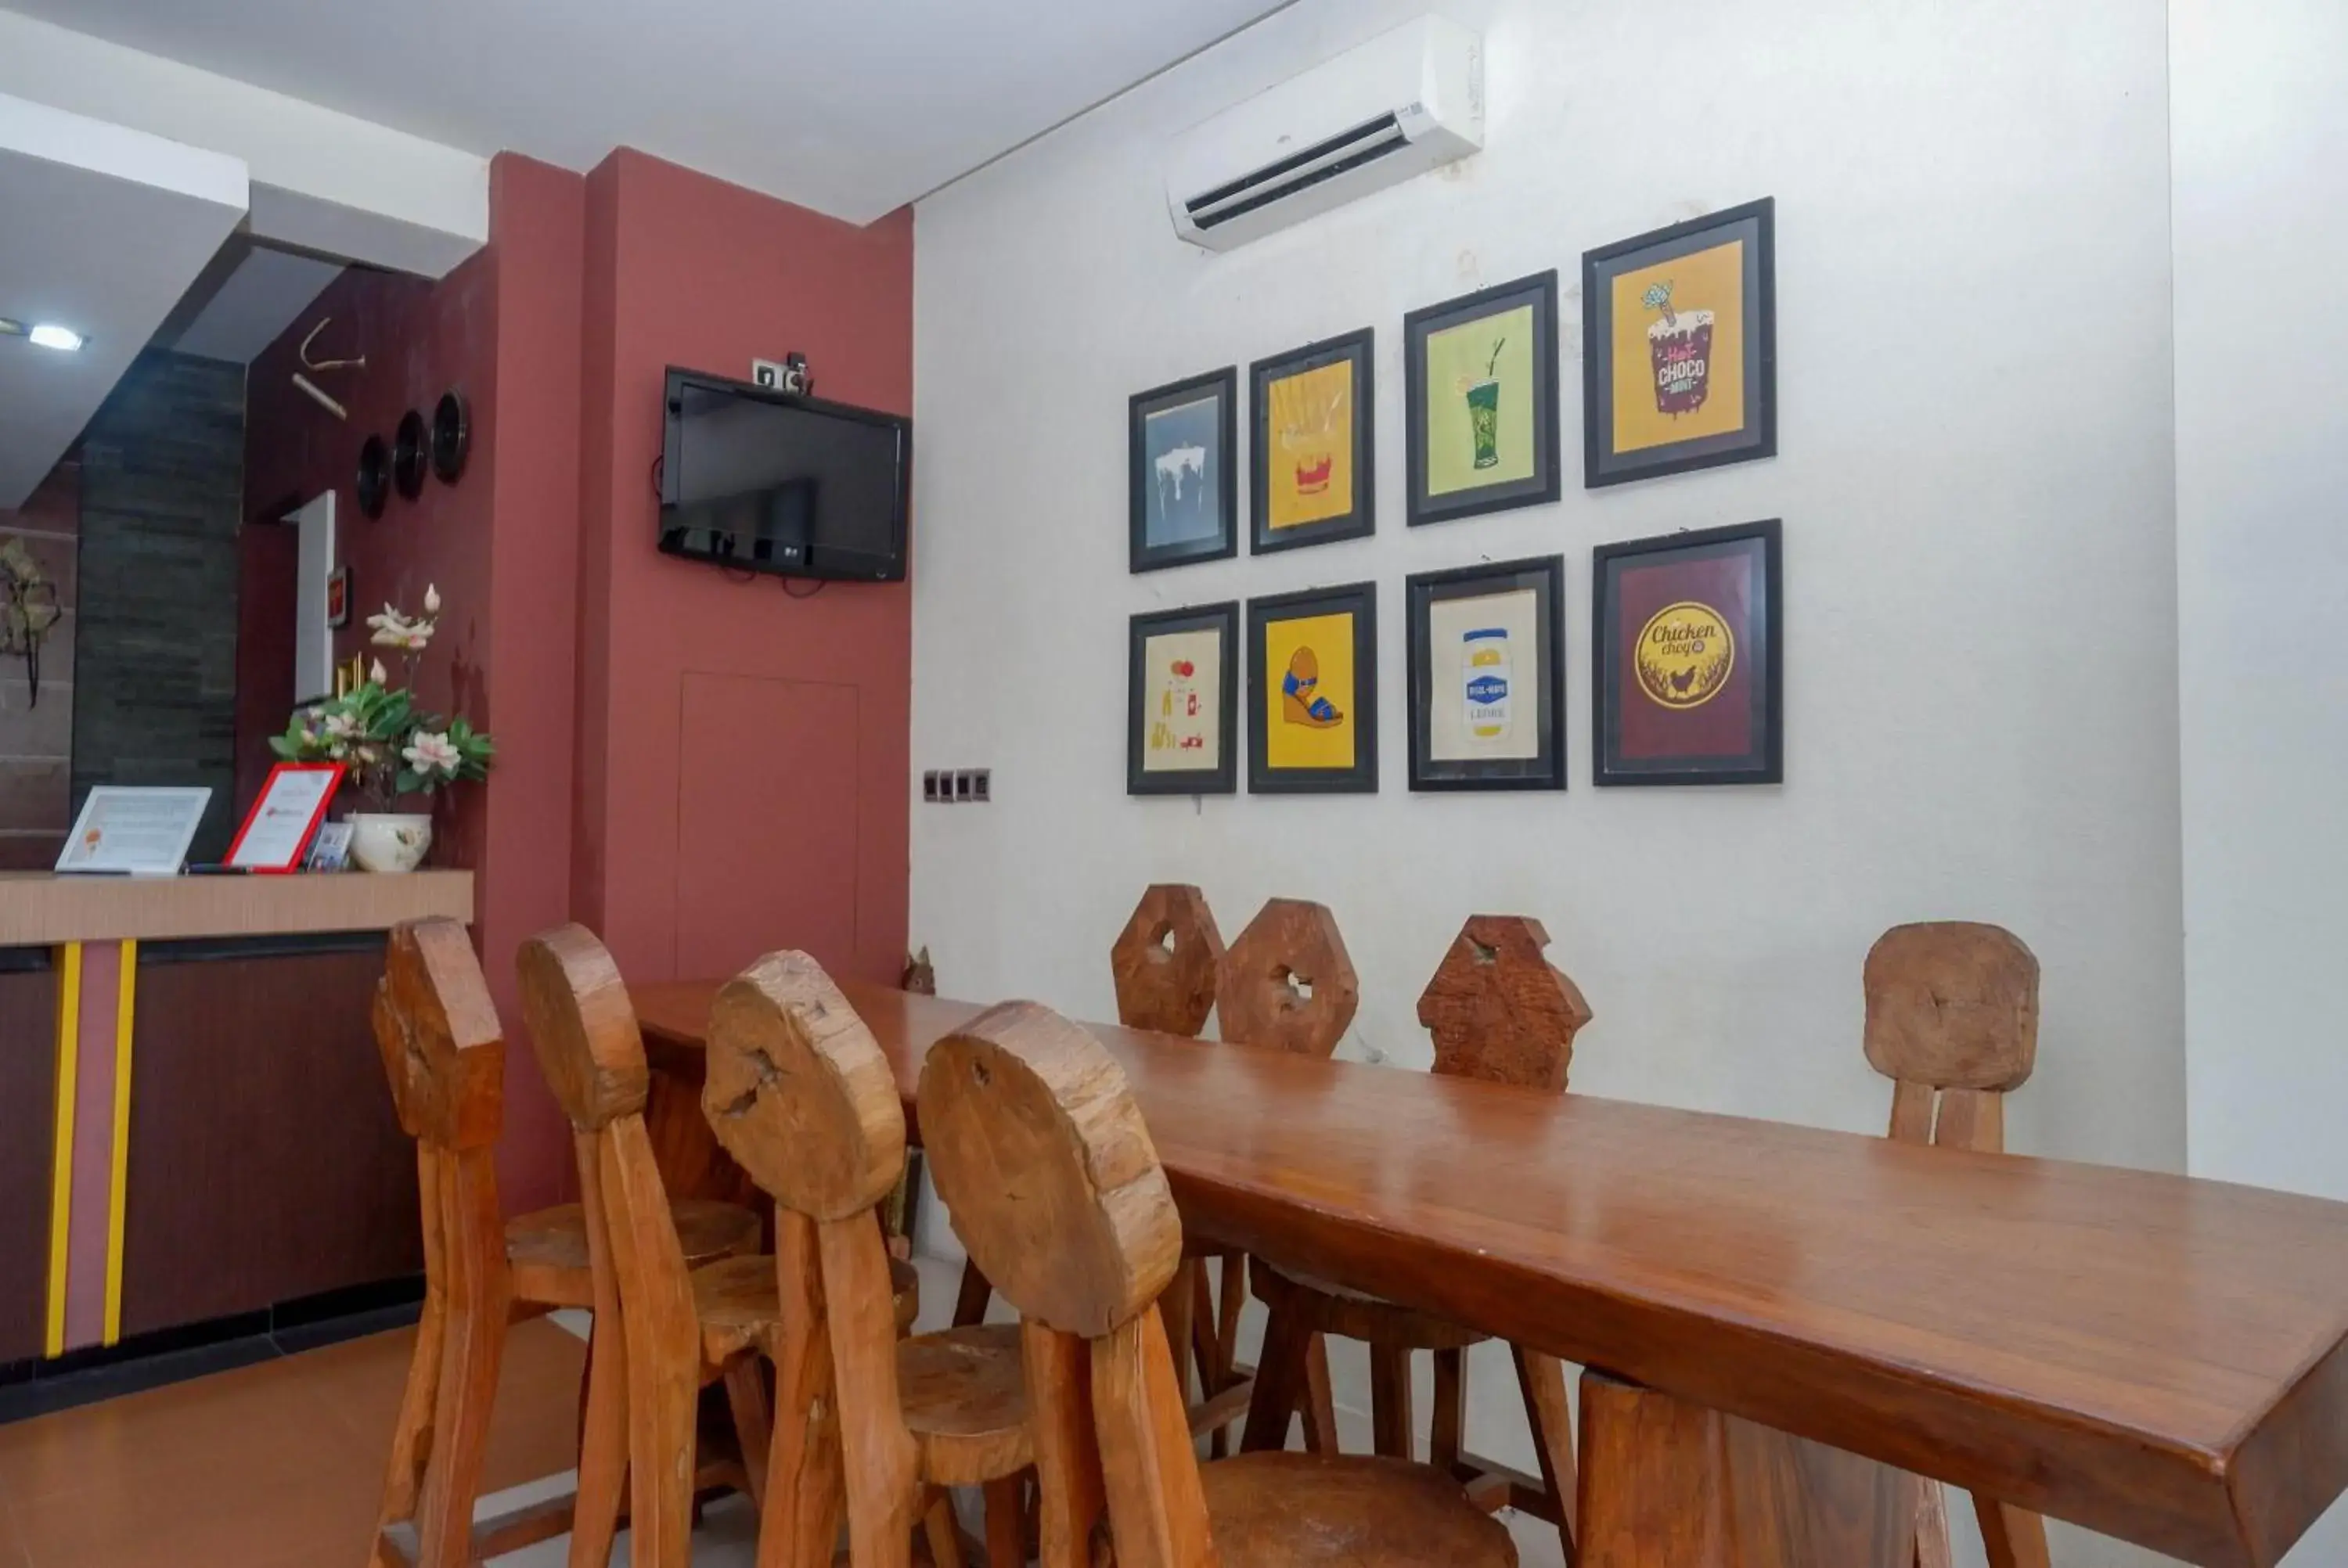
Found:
<box><xmin>1167</xmin><ymin>16</ymin><xmax>1484</xmax><ymax>251</ymax></box>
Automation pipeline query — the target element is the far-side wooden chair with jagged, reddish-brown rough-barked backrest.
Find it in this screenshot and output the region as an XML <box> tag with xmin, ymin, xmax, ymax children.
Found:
<box><xmin>1244</xmin><ymin>915</ymin><xmax>1590</xmax><ymax>1563</ymax></box>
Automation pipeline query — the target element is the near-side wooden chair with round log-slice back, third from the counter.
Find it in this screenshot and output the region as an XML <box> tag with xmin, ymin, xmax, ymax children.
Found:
<box><xmin>702</xmin><ymin>953</ymin><xmax>1035</xmax><ymax>1568</ymax></box>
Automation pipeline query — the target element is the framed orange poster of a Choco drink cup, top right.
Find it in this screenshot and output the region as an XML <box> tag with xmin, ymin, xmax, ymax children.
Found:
<box><xmin>1583</xmin><ymin>200</ymin><xmax>1777</xmax><ymax>488</ymax></box>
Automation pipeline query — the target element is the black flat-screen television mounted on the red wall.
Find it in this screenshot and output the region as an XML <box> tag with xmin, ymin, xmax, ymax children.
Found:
<box><xmin>660</xmin><ymin>366</ymin><xmax>913</xmax><ymax>582</ymax></box>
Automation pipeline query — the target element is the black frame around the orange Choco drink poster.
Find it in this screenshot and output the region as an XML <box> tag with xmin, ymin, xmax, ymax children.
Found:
<box><xmin>1583</xmin><ymin>197</ymin><xmax>1777</xmax><ymax>491</ymax></box>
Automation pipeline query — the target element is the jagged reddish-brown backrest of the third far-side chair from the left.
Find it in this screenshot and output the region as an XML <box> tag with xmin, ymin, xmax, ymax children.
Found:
<box><xmin>1418</xmin><ymin>915</ymin><xmax>1590</xmax><ymax>1094</ymax></box>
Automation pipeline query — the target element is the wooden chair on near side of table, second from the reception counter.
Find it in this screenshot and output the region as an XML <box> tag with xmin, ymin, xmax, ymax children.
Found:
<box><xmin>514</xmin><ymin>925</ymin><xmax>826</xmax><ymax>1568</ymax></box>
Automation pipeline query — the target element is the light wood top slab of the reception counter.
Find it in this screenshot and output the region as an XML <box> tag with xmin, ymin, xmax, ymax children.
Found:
<box><xmin>0</xmin><ymin>871</ymin><xmax>472</xmax><ymax>948</ymax></box>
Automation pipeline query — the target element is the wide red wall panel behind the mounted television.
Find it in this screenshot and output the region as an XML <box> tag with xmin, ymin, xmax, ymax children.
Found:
<box><xmin>573</xmin><ymin>150</ymin><xmax>913</xmax><ymax>979</ymax></box>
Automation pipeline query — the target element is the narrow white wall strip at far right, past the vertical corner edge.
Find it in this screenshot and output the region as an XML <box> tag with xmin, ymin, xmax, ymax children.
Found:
<box><xmin>2170</xmin><ymin>0</ymin><xmax>2348</xmax><ymax>1568</ymax></box>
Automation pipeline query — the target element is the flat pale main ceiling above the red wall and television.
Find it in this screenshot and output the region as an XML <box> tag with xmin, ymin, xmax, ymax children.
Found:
<box><xmin>0</xmin><ymin>0</ymin><xmax>1289</xmax><ymax>223</ymax></box>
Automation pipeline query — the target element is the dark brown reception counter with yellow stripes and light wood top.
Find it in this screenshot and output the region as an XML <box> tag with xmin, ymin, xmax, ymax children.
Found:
<box><xmin>0</xmin><ymin>871</ymin><xmax>472</xmax><ymax>1366</ymax></box>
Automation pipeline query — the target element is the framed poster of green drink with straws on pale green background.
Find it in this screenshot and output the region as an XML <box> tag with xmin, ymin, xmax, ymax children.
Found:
<box><xmin>1402</xmin><ymin>270</ymin><xmax>1561</xmax><ymax>528</ymax></box>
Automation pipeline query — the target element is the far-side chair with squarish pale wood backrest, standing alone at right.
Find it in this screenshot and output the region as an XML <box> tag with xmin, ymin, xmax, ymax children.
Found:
<box><xmin>1864</xmin><ymin>920</ymin><xmax>2047</xmax><ymax>1568</ymax></box>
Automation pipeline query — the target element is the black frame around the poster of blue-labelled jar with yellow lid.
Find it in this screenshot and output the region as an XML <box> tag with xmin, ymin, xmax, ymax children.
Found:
<box><xmin>1402</xmin><ymin>556</ymin><xmax>1566</xmax><ymax>791</ymax></box>
